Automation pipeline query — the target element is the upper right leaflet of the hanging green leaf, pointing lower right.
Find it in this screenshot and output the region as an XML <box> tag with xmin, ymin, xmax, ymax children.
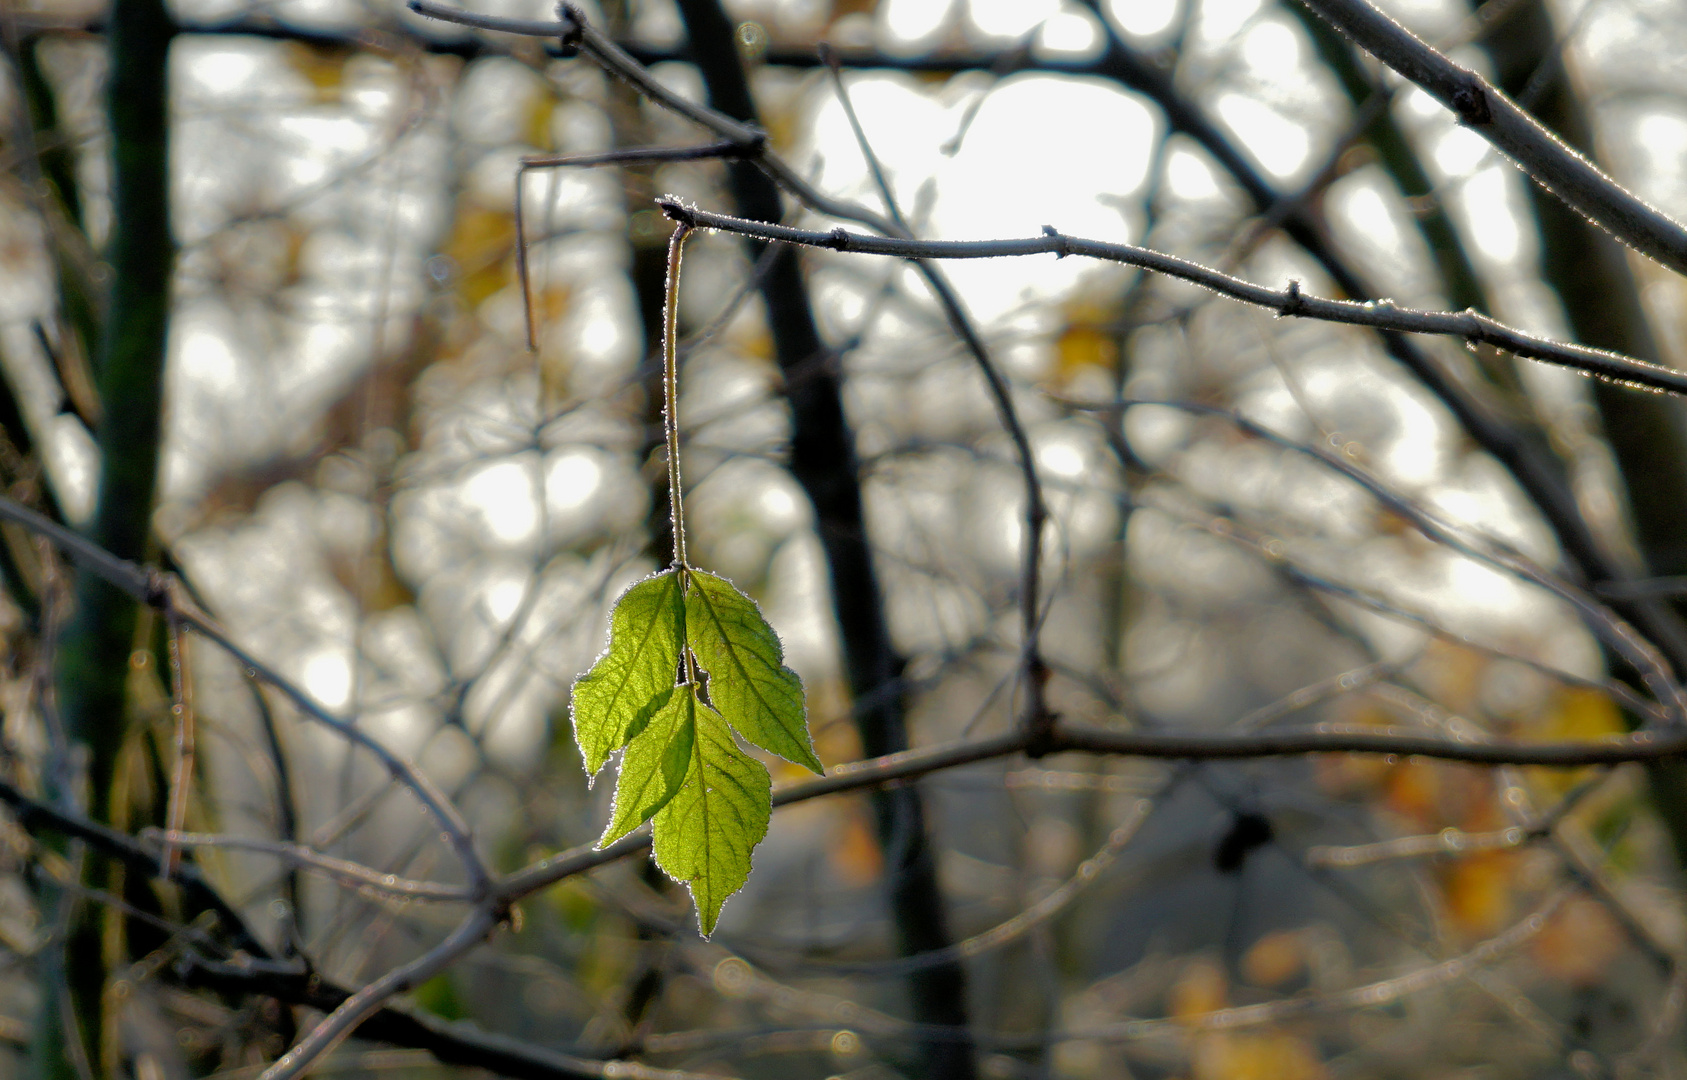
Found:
<box><xmin>685</xmin><ymin>570</ymin><xmax>825</xmax><ymax>773</ymax></box>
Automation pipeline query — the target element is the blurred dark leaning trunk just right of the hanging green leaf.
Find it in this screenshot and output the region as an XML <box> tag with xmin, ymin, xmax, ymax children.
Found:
<box><xmin>661</xmin><ymin>0</ymin><xmax>977</xmax><ymax>1080</ymax></box>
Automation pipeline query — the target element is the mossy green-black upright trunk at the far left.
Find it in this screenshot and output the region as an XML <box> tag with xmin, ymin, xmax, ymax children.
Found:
<box><xmin>35</xmin><ymin>0</ymin><xmax>174</xmax><ymax>1078</ymax></box>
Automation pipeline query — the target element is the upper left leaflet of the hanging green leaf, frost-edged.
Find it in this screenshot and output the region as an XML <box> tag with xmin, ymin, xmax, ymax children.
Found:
<box><xmin>572</xmin><ymin>570</ymin><xmax>685</xmax><ymax>776</ymax></box>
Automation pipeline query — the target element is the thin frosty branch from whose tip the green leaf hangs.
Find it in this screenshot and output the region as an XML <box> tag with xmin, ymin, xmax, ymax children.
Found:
<box><xmin>656</xmin><ymin>197</ymin><xmax>1687</xmax><ymax>393</ymax></box>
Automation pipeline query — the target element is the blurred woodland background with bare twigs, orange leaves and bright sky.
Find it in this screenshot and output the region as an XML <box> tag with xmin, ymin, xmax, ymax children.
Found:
<box><xmin>0</xmin><ymin>0</ymin><xmax>1687</xmax><ymax>1080</ymax></box>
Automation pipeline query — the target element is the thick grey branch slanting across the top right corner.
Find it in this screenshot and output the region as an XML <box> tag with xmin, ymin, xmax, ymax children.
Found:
<box><xmin>1302</xmin><ymin>0</ymin><xmax>1687</xmax><ymax>278</ymax></box>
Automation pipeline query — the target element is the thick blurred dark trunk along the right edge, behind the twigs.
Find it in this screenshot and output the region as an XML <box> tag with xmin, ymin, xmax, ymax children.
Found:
<box><xmin>1486</xmin><ymin>0</ymin><xmax>1687</xmax><ymax>866</ymax></box>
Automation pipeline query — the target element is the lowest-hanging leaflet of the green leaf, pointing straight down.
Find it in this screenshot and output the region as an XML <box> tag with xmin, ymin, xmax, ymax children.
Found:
<box><xmin>653</xmin><ymin>691</ymin><xmax>773</xmax><ymax>937</ymax></box>
